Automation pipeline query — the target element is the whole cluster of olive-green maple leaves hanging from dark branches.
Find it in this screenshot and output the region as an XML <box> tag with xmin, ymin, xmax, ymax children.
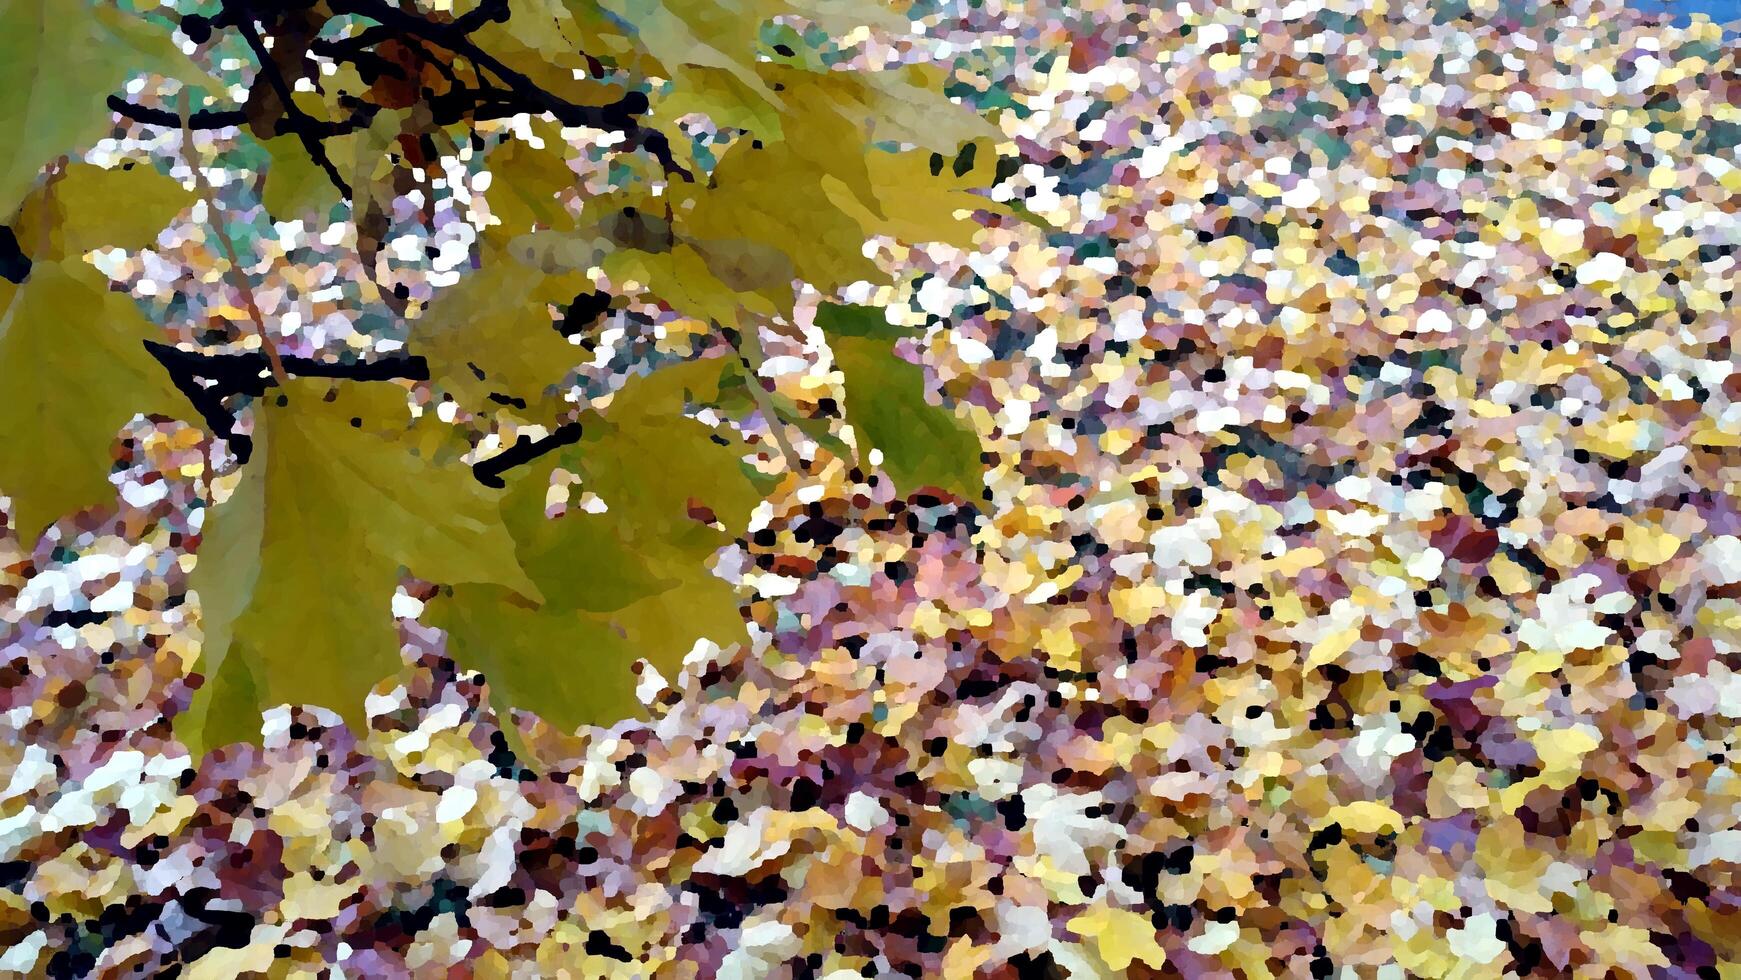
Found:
<box><xmin>0</xmin><ymin>0</ymin><xmax>996</xmax><ymax>745</ymax></box>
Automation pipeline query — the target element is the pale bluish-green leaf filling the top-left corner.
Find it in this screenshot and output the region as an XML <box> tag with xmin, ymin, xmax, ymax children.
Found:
<box><xmin>0</xmin><ymin>0</ymin><xmax>192</xmax><ymax>218</ymax></box>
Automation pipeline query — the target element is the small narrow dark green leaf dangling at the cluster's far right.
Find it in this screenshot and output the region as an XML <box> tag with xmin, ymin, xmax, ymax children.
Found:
<box><xmin>818</xmin><ymin>313</ymin><xmax>984</xmax><ymax>501</ymax></box>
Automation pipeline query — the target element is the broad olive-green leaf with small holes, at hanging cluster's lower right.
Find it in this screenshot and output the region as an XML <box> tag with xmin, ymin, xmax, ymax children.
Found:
<box><xmin>428</xmin><ymin>360</ymin><xmax>761</xmax><ymax>729</ymax></box>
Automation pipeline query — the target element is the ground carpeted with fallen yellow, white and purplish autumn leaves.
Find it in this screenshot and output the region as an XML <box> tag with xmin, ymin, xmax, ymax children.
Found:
<box><xmin>0</xmin><ymin>0</ymin><xmax>1741</xmax><ymax>980</ymax></box>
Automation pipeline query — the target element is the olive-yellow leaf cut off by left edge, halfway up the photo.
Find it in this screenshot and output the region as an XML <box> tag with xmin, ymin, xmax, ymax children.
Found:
<box><xmin>0</xmin><ymin>258</ymin><xmax>198</xmax><ymax>541</ymax></box>
